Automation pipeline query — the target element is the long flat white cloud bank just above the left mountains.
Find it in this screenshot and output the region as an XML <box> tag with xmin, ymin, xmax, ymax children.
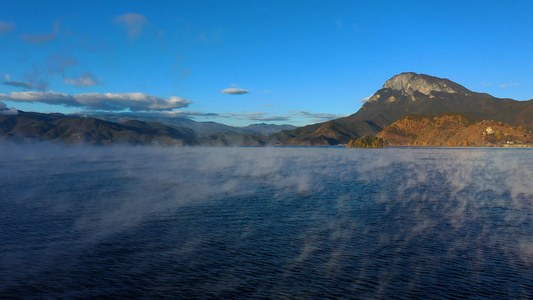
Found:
<box><xmin>0</xmin><ymin>91</ymin><xmax>192</xmax><ymax>111</ymax></box>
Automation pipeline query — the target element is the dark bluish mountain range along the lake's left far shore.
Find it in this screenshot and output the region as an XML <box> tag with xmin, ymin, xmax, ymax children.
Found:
<box><xmin>0</xmin><ymin>111</ymin><xmax>295</xmax><ymax>146</ymax></box>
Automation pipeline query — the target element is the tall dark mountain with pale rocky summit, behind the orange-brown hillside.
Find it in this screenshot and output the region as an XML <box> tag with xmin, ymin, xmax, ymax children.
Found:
<box><xmin>274</xmin><ymin>73</ymin><xmax>533</xmax><ymax>145</ymax></box>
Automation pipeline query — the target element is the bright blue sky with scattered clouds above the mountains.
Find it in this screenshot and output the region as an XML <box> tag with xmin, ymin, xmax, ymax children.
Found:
<box><xmin>0</xmin><ymin>0</ymin><xmax>533</xmax><ymax>126</ymax></box>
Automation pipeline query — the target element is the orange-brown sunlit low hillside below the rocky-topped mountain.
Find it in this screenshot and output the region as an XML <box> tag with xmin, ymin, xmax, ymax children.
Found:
<box><xmin>377</xmin><ymin>114</ymin><xmax>533</xmax><ymax>146</ymax></box>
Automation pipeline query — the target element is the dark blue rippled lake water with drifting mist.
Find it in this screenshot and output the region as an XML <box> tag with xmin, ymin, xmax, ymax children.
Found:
<box><xmin>0</xmin><ymin>144</ymin><xmax>533</xmax><ymax>299</ymax></box>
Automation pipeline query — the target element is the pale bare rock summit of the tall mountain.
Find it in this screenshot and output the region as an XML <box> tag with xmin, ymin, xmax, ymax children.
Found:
<box><xmin>383</xmin><ymin>72</ymin><xmax>467</xmax><ymax>95</ymax></box>
